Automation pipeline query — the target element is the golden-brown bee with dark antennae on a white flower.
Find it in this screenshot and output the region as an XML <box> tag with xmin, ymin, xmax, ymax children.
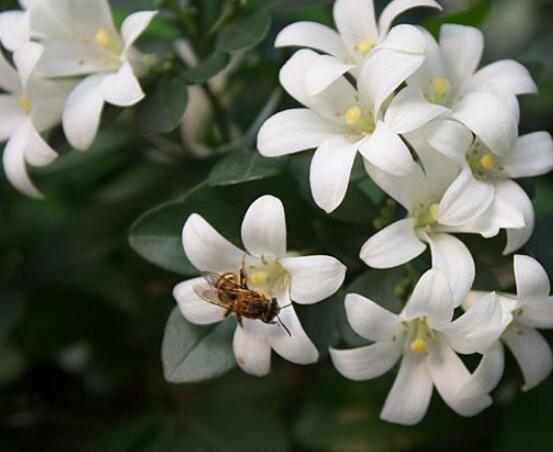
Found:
<box><xmin>193</xmin><ymin>261</ymin><xmax>291</xmax><ymax>336</ymax></box>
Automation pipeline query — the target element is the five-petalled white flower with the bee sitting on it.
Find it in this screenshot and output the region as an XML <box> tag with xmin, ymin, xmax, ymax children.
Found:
<box><xmin>174</xmin><ymin>196</ymin><xmax>346</xmax><ymax>376</ymax></box>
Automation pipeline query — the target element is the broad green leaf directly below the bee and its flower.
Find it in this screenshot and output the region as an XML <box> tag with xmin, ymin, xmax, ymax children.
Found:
<box><xmin>161</xmin><ymin>302</ymin><xmax>236</xmax><ymax>383</ymax></box>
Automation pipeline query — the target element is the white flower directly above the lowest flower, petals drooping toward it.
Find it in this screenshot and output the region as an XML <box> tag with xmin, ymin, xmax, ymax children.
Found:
<box><xmin>360</xmin><ymin>146</ymin><xmax>525</xmax><ymax>304</ymax></box>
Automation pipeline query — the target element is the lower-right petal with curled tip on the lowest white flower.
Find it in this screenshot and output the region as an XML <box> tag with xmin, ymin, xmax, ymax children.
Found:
<box><xmin>428</xmin><ymin>337</ymin><xmax>492</xmax><ymax>416</ymax></box>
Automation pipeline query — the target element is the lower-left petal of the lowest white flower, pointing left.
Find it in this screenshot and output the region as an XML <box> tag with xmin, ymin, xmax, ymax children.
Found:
<box><xmin>330</xmin><ymin>341</ymin><xmax>402</xmax><ymax>381</ymax></box>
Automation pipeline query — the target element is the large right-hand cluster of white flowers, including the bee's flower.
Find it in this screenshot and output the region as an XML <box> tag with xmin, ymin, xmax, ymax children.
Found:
<box><xmin>175</xmin><ymin>0</ymin><xmax>553</xmax><ymax>424</ymax></box>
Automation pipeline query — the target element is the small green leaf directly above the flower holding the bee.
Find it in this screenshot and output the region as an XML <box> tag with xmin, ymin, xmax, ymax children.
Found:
<box><xmin>209</xmin><ymin>149</ymin><xmax>287</xmax><ymax>186</ymax></box>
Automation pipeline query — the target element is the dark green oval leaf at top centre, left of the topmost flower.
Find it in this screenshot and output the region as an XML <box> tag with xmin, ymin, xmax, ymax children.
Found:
<box><xmin>215</xmin><ymin>12</ymin><xmax>271</xmax><ymax>53</ymax></box>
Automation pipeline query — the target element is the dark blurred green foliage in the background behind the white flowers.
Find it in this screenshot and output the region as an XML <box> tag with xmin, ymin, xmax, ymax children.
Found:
<box><xmin>0</xmin><ymin>0</ymin><xmax>553</xmax><ymax>452</ymax></box>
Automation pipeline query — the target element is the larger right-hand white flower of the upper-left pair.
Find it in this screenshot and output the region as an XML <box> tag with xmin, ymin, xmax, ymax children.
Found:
<box><xmin>30</xmin><ymin>0</ymin><xmax>156</xmax><ymax>150</ymax></box>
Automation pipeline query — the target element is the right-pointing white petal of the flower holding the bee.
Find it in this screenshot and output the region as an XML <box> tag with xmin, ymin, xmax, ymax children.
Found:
<box><xmin>280</xmin><ymin>256</ymin><xmax>347</xmax><ymax>304</ymax></box>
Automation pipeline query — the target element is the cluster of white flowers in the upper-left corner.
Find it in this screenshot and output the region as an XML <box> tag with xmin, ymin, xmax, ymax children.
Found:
<box><xmin>0</xmin><ymin>0</ymin><xmax>156</xmax><ymax>197</ymax></box>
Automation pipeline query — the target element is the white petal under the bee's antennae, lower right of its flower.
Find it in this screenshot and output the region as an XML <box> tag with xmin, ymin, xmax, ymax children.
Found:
<box><xmin>268</xmin><ymin>306</ymin><xmax>319</xmax><ymax>364</ymax></box>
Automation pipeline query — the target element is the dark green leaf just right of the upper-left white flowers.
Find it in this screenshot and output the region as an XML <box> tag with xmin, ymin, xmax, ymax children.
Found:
<box><xmin>136</xmin><ymin>76</ymin><xmax>188</xmax><ymax>133</ymax></box>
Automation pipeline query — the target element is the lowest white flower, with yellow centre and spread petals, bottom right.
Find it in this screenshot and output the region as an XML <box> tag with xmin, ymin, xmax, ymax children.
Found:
<box><xmin>330</xmin><ymin>269</ymin><xmax>509</xmax><ymax>425</ymax></box>
